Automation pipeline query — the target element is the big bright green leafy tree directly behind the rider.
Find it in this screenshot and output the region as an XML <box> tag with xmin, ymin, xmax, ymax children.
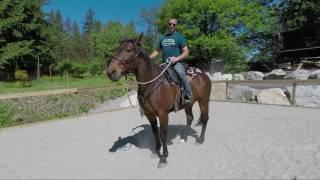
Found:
<box><xmin>158</xmin><ymin>0</ymin><xmax>273</xmax><ymax>72</ymax></box>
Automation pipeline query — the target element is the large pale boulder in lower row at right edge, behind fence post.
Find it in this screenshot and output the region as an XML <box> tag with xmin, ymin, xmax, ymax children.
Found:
<box><xmin>287</xmin><ymin>86</ymin><xmax>320</xmax><ymax>107</ymax></box>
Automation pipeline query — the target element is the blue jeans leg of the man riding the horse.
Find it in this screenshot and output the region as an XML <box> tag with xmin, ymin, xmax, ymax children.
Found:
<box><xmin>172</xmin><ymin>62</ymin><xmax>192</xmax><ymax>100</ymax></box>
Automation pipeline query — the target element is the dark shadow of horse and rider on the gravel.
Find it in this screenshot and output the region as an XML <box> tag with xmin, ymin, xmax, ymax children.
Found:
<box><xmin>109</xmin><ymin>124</ymin><xmax>197</xmax><ymax>152</ymax></box>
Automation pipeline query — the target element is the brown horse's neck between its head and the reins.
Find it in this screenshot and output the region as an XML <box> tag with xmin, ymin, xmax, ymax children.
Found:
<box><xmin>136</xmin><ymin>57</ymin><xmax>161</xmax><ymax>87</ymax></box>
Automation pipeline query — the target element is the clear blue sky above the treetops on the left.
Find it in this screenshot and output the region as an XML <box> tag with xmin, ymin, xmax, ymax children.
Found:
<box><xmin>43</xmin><ymin>0</ymin><xmax>163</xmax><ymax>31</ymax></box>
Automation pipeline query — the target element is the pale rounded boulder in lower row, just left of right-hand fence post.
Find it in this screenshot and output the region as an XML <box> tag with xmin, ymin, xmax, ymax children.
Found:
<box><xmin>257</xmin><ymin>88</ymin><xmax>290</xmax><ymax>105</ymax></box>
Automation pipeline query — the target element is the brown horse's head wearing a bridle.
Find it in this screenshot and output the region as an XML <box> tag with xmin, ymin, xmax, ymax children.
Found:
<box><xmin>106</xmin><ymin>33</ymin><xmax>142</xmax><ymax>81</ymax></box>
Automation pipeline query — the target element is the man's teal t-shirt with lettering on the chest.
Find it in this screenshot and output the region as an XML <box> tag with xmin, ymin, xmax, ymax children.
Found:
<box><xmin>158</xmin><ymin>32</ymin><xmax>187</xmax><ymax>62</ymax></box>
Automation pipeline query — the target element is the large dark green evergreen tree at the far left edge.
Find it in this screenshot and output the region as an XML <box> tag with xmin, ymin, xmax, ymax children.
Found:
<box><xmin>0</xmin><ymin>0</ymin><xmax>50</xmax><ymax>77</ymax></box>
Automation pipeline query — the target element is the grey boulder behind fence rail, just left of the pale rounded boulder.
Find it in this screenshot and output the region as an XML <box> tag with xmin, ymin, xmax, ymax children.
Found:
<box><xmin>229</xmin><ymin>85</ymin><xmax>258</xmax><ymax>101</ymax></box>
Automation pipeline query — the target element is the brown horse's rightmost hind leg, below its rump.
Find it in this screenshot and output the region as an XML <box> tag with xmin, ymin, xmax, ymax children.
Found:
<box><xmin>196</xmin><ymin>100</ymin><xmax>209</xmax><ymax>144</ymax></box>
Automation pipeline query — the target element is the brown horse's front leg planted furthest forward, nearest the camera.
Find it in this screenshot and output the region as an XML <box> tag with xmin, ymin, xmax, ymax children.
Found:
<box><xmin>158</xmin><ymin>113</ymin><xmax>169</xmax><ymax>168</ymax></box>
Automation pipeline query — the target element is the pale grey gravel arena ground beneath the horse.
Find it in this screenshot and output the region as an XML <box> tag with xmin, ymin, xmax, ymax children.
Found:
<box><xmin>0</xmin><ymin>102</ymin><xmax>320</xmax><ymax>179</ymax></box>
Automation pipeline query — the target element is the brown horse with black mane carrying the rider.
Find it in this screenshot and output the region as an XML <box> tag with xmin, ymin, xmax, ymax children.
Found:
<box><xmin>106</xmin><ymin>35</ymin><xmax>211</xmax><ymax>167</ymax></box>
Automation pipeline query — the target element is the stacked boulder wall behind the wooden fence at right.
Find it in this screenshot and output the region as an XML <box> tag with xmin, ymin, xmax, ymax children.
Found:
<box><xmin>207</xmin><ymin>69</ymin><xmax>320</xmax><ymax>108</ymax></box>
